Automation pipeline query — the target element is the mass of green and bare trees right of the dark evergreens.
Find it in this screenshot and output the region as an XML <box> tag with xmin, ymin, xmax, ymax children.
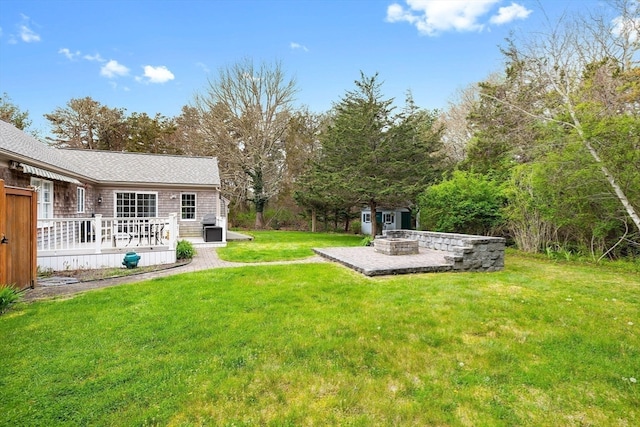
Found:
<box><xmin>432</xmin><ymin>0</ymin><xmax>640</xmax><ymax>258</ymax></box>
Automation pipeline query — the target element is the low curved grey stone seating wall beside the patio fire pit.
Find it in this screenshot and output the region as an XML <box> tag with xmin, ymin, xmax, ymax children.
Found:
<box><xmin>383</xmin><ymin>230</ymin><xmax>506</xmax><ymax>271</ymax></box>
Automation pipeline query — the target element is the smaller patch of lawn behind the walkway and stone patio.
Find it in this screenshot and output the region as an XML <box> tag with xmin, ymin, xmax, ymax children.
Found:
<box><xmin>218</xmin><ymin>231</ymin><xmax>362</xmax><ymax>262</ymax></box>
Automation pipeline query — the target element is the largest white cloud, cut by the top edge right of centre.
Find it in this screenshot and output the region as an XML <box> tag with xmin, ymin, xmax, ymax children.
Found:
<box><xmin>386</xmin><ymin>0</ymin><xmax>531</xmax><ymax>36</ymax></box>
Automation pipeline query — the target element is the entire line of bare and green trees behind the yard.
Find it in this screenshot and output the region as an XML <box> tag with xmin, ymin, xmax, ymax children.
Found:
<box><xmin>0</xmin><ymin>0</ymin><xmax>640</xmax><ymax>257</ymax></box>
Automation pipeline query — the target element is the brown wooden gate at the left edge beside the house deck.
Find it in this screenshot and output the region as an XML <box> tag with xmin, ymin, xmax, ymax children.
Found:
<box><xmin>0</xmin><ymin>179</ymin><xmax>38</xmax><ymax>290</ymax></box>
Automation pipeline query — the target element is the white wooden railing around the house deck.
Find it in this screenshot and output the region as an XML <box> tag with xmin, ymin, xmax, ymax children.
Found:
<box><xmin>38</xmin><ymin>214</ymin><xmax>178</xmax><ymax>254</ymax></box>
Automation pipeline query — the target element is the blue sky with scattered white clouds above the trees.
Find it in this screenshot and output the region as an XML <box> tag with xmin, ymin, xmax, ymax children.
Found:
<box><xmin>0</xmin><ymin>0</ymin><xmax>600</xmax><ymax>134</ymax></box>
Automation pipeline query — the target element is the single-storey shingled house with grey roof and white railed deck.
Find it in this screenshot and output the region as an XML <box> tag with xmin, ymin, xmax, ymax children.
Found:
<box><xmin>0</xmin><ymin>121</ymin><xmax>228</xmax><ymax>270</ymax></box>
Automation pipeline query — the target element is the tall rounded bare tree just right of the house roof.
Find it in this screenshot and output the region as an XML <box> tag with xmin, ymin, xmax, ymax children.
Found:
<box><xmin>195</xmin><ymin>59</ymin><xmax>296</xmax><ymax>228</ymax></box>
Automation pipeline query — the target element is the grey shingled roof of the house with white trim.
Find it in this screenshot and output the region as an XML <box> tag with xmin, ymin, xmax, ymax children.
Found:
<box><xmin>0</xmin><ymin>120</ymin><xmax>220</xmax><ymax>186</ymax></box>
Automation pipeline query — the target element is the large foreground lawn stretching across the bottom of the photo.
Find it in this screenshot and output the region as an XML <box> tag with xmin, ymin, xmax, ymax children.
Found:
<box><xmin>0</xmin><ymin>242</ymin><xmax>640</xmax><ymax>426</ymax></box>
